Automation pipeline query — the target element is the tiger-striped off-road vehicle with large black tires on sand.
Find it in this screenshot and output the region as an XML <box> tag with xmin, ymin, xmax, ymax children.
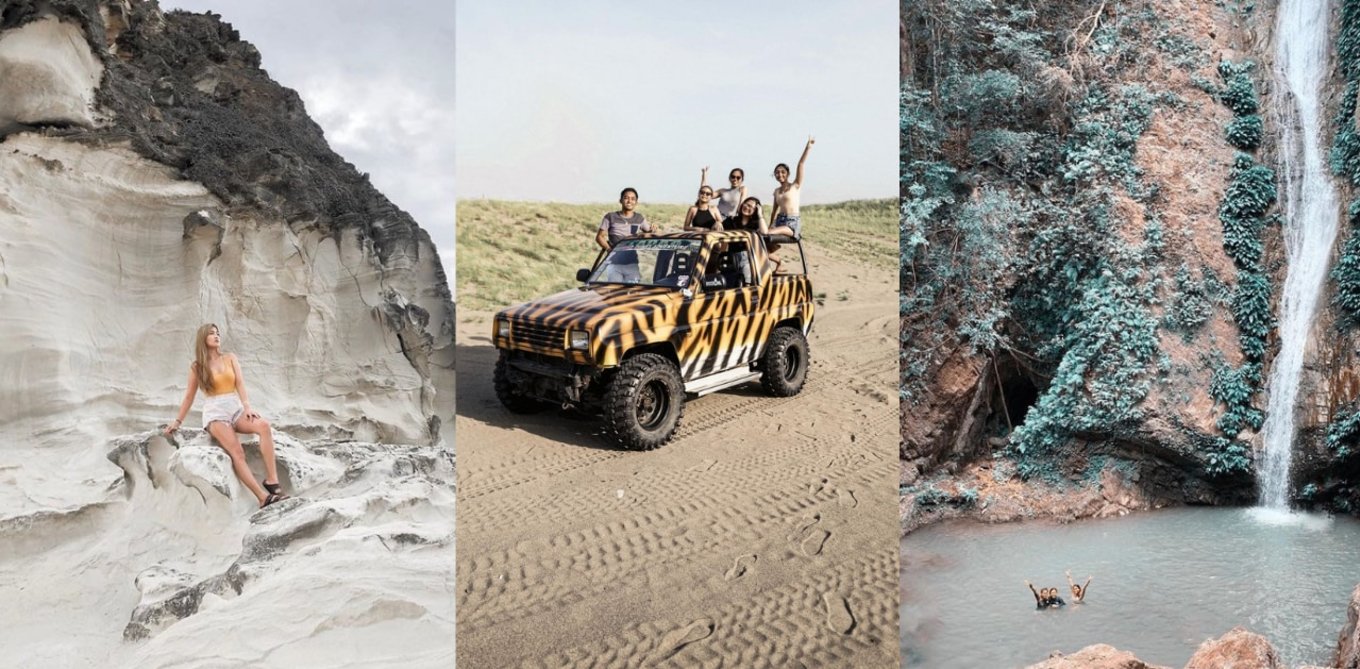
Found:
<box><xmin>492</xmin><ymin>230</ymin><xmax>813</xmax><ymax>450</ymax></box>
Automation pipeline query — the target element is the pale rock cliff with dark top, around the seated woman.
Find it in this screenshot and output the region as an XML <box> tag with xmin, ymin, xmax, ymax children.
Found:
<box><xmin>0</xmin><ymin>0</ymin><xmax>454</xmax><ymax>666</ymax></box>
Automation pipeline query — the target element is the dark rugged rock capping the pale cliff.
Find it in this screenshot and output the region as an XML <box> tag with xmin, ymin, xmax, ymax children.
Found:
<box><xmin>0</xmin><ymin>0</ymin><xmax>452</xmax><ymax>284</ymax></box>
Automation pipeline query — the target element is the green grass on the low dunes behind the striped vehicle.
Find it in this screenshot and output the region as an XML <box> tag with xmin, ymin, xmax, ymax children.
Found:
<box><xmin>457</xmin><ymin>199</ymin><xmax>898</xmax><ymax>311</ymax></box>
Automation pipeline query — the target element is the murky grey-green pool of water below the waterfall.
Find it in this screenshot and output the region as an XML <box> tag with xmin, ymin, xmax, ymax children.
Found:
<box><xmin>902</xmin><ymin>509</ymin><xmax>1360</xmax><ymax>669</ymax></box>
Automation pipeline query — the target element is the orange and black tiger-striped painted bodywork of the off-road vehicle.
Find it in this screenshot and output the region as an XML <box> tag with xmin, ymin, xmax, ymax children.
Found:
<box><xmin>492</xmin><ymin>231</ymin><xmax>813</xmax><ymax>382</ymax></box>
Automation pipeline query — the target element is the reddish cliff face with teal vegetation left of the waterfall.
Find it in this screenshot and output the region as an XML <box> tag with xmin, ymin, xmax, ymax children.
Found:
<box><xmin>900</xmin><ymin>0</ymin><xmax>1316</xmax><ymax>525</ymax></box>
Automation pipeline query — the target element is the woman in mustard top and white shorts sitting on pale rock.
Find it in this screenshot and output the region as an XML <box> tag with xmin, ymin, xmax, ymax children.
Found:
<box><xmin>165</xmin><ymin>324</ymin><xmax>288</xmax><ymax>509</ymax></box>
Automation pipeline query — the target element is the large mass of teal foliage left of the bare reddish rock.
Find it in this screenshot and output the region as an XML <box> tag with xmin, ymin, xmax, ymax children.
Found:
<box><xmin>900</xmin><ymin>0</ymin><xmax>1213</xmax><ymax>465</ymax></box>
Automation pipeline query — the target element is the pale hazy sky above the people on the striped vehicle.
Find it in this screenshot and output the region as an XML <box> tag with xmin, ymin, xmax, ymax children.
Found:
<box><xmin>457</xmin><ymin>0</ymin><xmax>899</xmax><ymax>207</ymax></box>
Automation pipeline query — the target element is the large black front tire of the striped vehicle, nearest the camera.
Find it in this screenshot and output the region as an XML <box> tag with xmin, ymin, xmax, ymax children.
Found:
<box><xmin>604</xmin><ymin>354</ymin><xmax>684</xmax><ymax>450</ymax></box>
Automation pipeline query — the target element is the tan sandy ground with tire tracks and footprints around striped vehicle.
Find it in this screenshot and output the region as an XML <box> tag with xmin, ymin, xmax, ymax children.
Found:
<box><xmin>456</xmin><ymin>249</ymin><xmax>898</xmax><ymax>668</ymax></box>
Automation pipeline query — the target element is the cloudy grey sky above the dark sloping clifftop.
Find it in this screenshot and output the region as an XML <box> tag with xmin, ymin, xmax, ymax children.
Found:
<box><xmin>160</xmin><ymin>0</ymin><xmax>454</xmax><ymax>271</ymax></box>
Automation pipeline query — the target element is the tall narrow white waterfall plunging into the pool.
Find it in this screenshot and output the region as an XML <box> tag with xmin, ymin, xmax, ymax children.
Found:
<box><xmin>1261</xmin><ymin>0</ymin><xmax>1340</xmax><ymax>509</ymax></box>
